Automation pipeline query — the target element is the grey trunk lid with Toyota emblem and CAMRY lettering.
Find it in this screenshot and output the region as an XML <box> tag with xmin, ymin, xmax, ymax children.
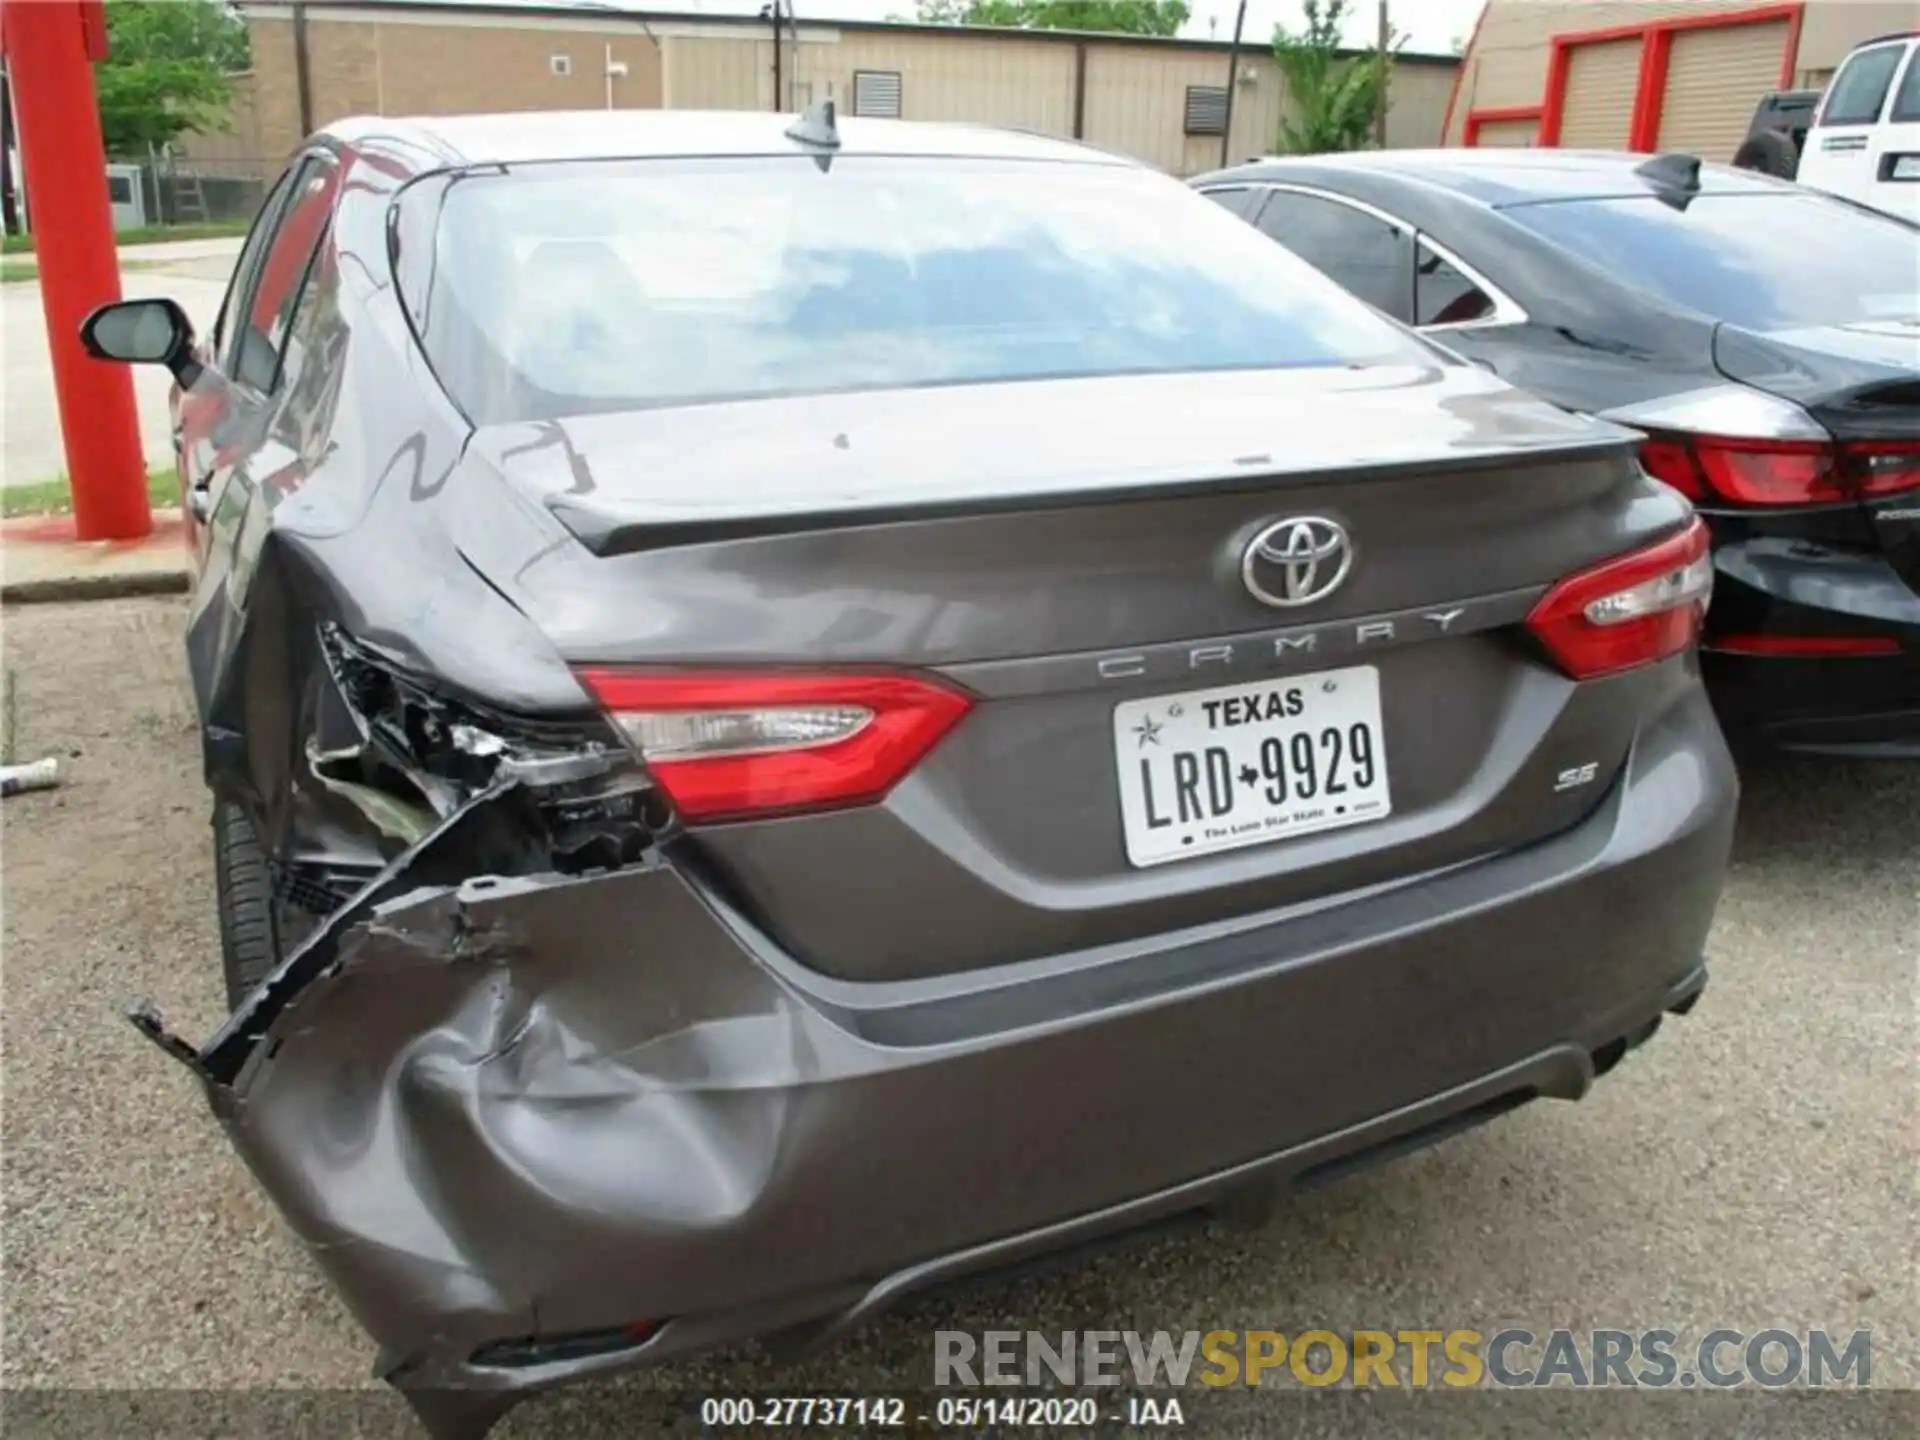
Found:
<box><xmin>463</xmin><ymin>365</ymin><xmax>1686</xmax><ymax>979</ymax></box>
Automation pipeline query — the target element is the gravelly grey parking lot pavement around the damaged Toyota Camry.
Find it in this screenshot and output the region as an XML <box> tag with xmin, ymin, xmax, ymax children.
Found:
<box><xmin>0</xmin><ymin>601</ymin><xmax>1920</xmax><ymax>1436</ymax></box>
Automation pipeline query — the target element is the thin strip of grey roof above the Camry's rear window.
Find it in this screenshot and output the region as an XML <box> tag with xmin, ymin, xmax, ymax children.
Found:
<box><xmin>326</xmin><ymin>109</ymin><xmax>1137</xmax><ymax>167</ymax></box>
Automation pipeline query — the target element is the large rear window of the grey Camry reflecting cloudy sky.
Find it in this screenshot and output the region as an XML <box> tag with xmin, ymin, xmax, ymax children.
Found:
<box><xmin>401</xmin><ymin>156</ymin><xmax>1430</xmax><ymax>422</ymax></box>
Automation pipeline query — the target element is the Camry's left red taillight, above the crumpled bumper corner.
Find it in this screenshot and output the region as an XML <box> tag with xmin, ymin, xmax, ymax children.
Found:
<box><xmin>564</xmin><ymin>666</ymin><xmax>972</xmax><ymax>822</ymax></box>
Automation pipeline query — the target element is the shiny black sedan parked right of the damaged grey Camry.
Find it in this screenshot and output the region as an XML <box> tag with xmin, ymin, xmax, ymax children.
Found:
<box><xmin>1194</xmin><ymin>150</ymin><xmax>1920</xmax><ymax>756</ymax></box>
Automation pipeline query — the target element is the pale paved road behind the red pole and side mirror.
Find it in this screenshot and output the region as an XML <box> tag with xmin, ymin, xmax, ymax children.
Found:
<box><xmin>0</xmin><ymin>240</ymin><xmax>240</xmax><ymax>486</ymax></box>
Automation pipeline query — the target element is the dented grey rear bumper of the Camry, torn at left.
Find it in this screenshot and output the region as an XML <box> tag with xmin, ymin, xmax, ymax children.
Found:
<box><xmin>221</xmin><ymin>687</ymin><xmax>1738</xmax><ymax>1434</ymax></box>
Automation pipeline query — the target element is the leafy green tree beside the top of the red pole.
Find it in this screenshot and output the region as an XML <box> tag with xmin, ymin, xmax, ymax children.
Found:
<box><xmin>94</xmin><ymin>0</ymin><xmax>250</xmax><ymax>157</ymax></box>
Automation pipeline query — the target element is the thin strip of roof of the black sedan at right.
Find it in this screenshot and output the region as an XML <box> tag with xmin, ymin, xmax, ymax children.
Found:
<box><xmin>1206</xmin><ymin>148</ymin><xmax>1795</xmax><ymax>209</ymax></box>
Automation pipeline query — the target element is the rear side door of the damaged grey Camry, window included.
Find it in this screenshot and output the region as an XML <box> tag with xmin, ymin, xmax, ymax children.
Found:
<box><xmin>179</xmin><ymin>150</ymin><xmax>340</xmax><ymax>714</ymax></box>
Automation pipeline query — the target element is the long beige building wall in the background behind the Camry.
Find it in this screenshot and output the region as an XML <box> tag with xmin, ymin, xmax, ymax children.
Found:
<box><xmin>224</xmin><ymin>2</ymin><xmax>1455</xmax><ymax>175</ymax></box>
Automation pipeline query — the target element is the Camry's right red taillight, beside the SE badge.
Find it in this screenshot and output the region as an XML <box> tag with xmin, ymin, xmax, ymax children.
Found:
<box><xmin>1526</xmin><ymin>516</ymin><xmax>1713</xmax><ymax>680</ymax></box>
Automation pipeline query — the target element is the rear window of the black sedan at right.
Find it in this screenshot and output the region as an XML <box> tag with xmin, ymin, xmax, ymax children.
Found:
<box><xmin>1501</xmin><ymin>192</ymin><xmax>1920</xmax><ymax>330</ymax></box>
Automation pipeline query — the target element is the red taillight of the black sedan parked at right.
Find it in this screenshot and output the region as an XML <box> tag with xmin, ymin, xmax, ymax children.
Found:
<box><xmin>1640</xmin><ymin>434</ymin><xmax>1920</xmax><ymax>505</ymax></box>
